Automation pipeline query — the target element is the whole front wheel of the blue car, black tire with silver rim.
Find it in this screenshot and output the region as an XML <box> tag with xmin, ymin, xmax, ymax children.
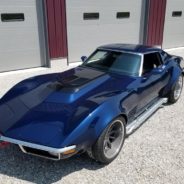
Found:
<box><xmin>90</xmin><ymin>117</ymin><xmax>126</xmax><ymax>164</ymax></box>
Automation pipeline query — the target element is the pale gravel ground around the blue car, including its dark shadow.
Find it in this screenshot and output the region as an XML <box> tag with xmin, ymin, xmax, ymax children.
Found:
<box><xmin>0</xmin><ymin>62</ymin><xmax>184</xmax><ymax>184</ymax></box>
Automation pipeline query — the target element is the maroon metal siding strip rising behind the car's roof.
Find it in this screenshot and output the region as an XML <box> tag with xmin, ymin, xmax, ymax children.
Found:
<box><xmin>146</xmin><ymin>0</ymin><xmax>167</xmax><ymax>46</ymax></box>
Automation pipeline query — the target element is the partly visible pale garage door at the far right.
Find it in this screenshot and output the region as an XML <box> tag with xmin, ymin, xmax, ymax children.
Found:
<box><xmin>163</xmin><ymin>0</ymin><xmax>184</xmax><ymax>48</ymax></box>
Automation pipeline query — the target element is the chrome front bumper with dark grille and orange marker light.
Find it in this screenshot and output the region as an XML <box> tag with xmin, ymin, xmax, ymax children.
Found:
<box><xmin>0</xmin><ymin>136</ymin><xmax>77</xmax><ymax>160</ymax></box>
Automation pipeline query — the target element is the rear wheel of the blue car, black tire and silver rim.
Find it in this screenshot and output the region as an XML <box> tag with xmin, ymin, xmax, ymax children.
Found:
<box><xmin>168</xmin><ymin>75</ymin><xmax>183</xmax><ymax>104</ymax></box>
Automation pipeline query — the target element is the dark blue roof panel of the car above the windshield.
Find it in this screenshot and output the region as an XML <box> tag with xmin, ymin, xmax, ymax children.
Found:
<box><xmin>98</xmin><ymin>43</ymin><xmax>161</xmax><ymax>54</ymax></box>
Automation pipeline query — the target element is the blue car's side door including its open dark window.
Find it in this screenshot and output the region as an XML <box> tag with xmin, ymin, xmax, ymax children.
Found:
<box><xmin>138</xmin><ymin>52</ymin><xmax>170</xmax><ymax>111</ymax></box>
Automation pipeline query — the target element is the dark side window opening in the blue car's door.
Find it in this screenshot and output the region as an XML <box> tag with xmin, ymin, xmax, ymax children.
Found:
<box><xmin>142</xmin><ymin>52</ymin><xmax>163</xmax><ymax>75</ymax></box>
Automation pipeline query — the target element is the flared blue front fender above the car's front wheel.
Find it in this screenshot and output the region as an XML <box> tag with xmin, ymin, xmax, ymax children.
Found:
<box><xmin>61</xmin><ymin>99</ymin><xmax>126</xmax><ymax>150</ymax></box>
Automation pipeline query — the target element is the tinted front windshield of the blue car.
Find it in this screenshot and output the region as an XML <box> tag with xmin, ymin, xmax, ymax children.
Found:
<box><xmin>83</xmin><ymin>50</ymin><xmax>141</xmax><ymax>75</ymax></box>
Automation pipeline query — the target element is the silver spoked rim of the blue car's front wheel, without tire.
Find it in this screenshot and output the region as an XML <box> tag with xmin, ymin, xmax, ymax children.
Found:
<box><xmin>103</xmin><ymin>120</ymin><xmax>125</xmax><ymax>159</ymax></box>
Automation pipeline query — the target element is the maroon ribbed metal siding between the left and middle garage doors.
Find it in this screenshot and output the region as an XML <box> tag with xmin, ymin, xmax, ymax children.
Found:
<box><xmin>46</xmin><ymin>0</ymin><xmax>67</xmax><ymax>59</ymax></box>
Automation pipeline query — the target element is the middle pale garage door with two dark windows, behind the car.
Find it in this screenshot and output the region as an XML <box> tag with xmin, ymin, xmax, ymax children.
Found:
<box><xmin>66</xmin><ymin>0</ymin><xmax>142</xmax><ymax>62</ymax></box>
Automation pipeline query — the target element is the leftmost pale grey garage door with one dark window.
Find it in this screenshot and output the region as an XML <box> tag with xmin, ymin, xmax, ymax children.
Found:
<box><xmin>0</xmin><ymin>0</ymin><xmax>45</xmax><ymax>71</ymax></box>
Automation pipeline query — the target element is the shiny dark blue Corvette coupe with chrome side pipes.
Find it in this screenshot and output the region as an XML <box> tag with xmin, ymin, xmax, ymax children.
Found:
<box><xmin>0</xmin><ymin>44</ymin><xmax>183</xmax><ymax>164</ymax></box>
